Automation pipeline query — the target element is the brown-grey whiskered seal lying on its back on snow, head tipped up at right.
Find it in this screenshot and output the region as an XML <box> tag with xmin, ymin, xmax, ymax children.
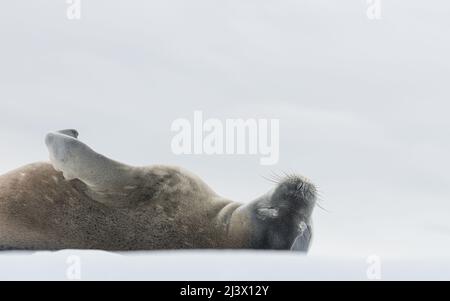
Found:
<box><xmin>0</xmin><ymin>130</ymin><xmax>317</xmax><ymax>252</ymax></box>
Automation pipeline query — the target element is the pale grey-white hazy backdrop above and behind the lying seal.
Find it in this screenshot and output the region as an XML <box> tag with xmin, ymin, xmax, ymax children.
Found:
<box><xmin>0</xmin><ymin>0</ymin><xmax>450</xmax><ymax>256</ymax></box>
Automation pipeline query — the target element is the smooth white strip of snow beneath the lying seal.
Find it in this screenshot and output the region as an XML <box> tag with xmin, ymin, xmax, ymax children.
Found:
<box><xmin>0</xmin><ymin>250</ymin><xmax>450</xmax><ymax>281</ymax></box>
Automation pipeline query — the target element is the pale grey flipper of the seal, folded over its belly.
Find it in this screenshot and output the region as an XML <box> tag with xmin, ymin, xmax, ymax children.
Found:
<box><xmin>45</xmin><ymin>130</ymin><xmax>136</xmax><ymax>205</ymax></box>
